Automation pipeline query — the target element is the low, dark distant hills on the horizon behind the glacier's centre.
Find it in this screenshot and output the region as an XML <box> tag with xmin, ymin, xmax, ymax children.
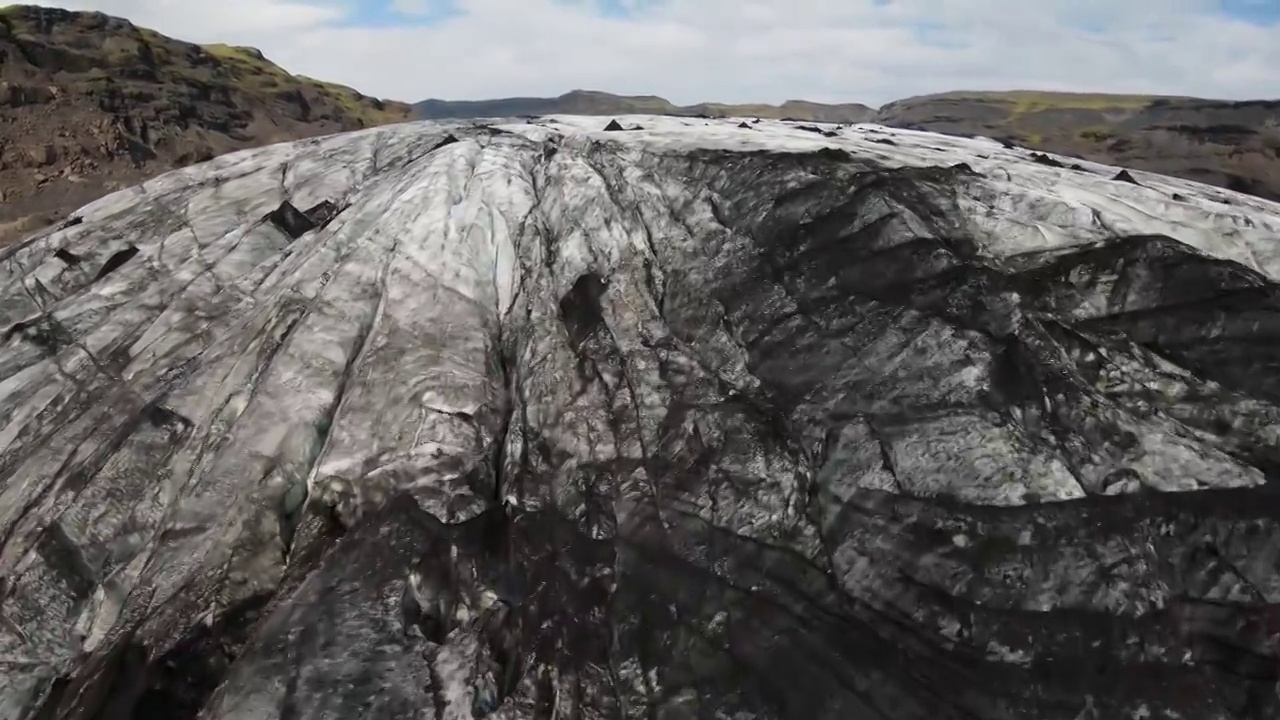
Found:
<box><xmin>413</xmin><ymin>90</ymin><xmax>876</xmax><ymax>123</ymax></box>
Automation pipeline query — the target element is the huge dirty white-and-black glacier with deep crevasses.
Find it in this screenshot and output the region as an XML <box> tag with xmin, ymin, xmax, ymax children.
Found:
<box><xmin>0</xmin><ymin>115</ymin><xmax>1280</xmax><ymax>720</ymax></box>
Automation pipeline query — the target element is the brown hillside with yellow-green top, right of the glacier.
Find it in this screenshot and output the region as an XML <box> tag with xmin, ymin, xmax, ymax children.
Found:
<box><xmin>876</xmin><ymin>92</ymin><xmax>1280</xmax><ymax>200</ymax></box>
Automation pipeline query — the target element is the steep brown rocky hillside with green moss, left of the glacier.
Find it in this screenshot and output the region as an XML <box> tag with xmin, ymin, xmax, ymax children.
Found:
<box><xmin>0</xmin><ymin>5</ymin><xmax>411</xmax><ymax>246</ymax></box>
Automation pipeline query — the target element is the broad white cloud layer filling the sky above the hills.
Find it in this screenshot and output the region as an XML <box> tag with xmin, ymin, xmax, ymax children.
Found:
<box><xmin>27</xmin><ymin>0</ymin><xmax>1280</xmax><ymax>105</ymax></box>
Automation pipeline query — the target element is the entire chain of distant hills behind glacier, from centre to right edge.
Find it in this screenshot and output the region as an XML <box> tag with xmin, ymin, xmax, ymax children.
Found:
<box><xmin>413</xmin><ymin>90</ymin><xmax>1280</xmax><ymax>200</ymax></box>
